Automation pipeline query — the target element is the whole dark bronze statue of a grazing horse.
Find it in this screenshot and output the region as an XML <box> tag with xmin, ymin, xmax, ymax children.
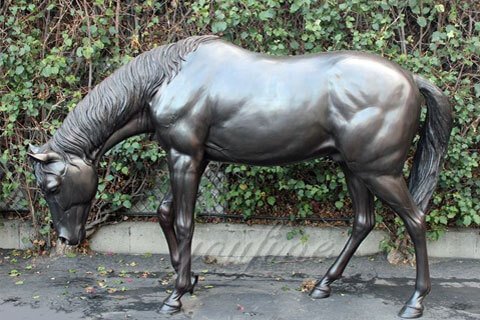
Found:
<box><xmin>30</xmin><ymin>36</ymin><xmax>452</xmax><ymax>318</ymax></box>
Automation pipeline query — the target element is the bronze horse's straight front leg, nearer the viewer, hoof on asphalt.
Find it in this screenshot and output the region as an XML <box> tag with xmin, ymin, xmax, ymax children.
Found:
<box><xmin>161</xmin><ymin>150</ymin><xmax>207</xmax><ymax>313</ymax></box>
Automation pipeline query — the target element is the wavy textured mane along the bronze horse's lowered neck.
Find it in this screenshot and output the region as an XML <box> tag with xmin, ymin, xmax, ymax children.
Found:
<box><xmin>48</xmin><ymin>35</ymin><xmax>218</xmax><ymax>160</ymax></box>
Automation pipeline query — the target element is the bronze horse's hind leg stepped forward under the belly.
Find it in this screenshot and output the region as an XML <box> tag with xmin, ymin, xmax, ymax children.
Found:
<box><xmin>310</xmin><ymin>165</ymin><xmax>375</xmax><ymax>299</ymax></box>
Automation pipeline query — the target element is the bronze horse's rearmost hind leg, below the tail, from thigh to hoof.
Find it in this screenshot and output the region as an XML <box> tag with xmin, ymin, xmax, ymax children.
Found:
<box><xmin>362</xmin><ymin>174</ymin><xmax>431</xmax><ymax>319</ymax></box>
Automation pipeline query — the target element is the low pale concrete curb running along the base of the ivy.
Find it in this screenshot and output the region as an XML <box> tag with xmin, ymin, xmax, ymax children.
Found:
<box><xmin>0</xmin><ymin>220</ymin><xmax>480</xmax><ymax>262</ymax></box>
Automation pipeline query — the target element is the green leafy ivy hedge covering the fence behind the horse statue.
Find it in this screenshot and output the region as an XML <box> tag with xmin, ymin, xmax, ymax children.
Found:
<box><xmin>0</xmin><ymin>0</ymin><xmax>480</xmax><ymax>245</ymax></box>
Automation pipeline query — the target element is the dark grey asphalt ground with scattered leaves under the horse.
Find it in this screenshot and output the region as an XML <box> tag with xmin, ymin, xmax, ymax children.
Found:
<box><xmin>0</xmin><ymin>250</ymin><xmax>480</xmax><ymax>320</ymax></box>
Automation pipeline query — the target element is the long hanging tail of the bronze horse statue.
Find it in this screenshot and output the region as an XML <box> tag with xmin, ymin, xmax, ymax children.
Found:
<box><xmin>408</xmin><ymin>75</ymin><xmax>453</xmax><ymax>212</ymax></box>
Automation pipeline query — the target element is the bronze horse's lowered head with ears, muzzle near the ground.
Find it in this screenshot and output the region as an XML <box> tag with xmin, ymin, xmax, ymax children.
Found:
<box><xmin>28</xmin><ymin>145</ymin><xmax>98</xmax><ymax>245</ymax></box>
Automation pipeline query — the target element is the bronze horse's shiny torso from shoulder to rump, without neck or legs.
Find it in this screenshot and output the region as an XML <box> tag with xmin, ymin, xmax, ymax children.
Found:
<box><xmin>152</xmin><ymin>41</ymin><xmax>418</xmax><ymax>169</ymax></box>
